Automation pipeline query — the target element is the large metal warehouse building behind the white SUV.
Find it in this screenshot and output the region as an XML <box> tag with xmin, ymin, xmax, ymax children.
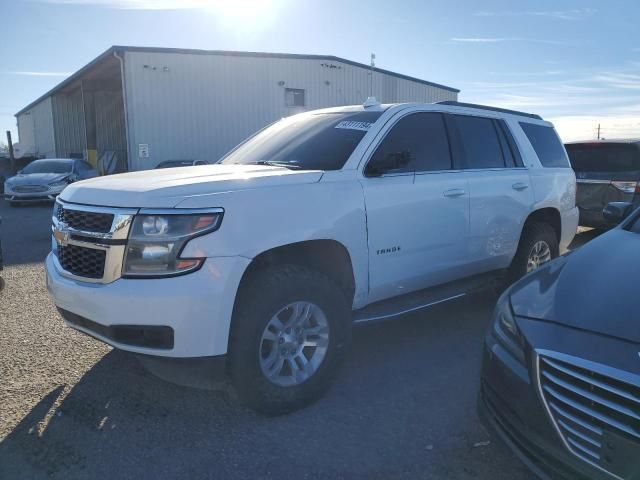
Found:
<box><xmin>16</xmin><ymin>46</ymin><xmax>459</xmax><ymax>173</ymax></box>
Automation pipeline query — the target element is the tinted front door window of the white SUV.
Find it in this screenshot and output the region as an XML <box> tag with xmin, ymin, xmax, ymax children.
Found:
<box><xmin>367</xmin><ymin>113</ymin><xmax>451</xmax><ymax>172</ymax></box>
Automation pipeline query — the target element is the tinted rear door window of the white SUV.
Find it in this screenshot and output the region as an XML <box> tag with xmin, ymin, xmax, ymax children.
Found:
<box><xmin>453</xmin><ymin>115</ymin><xmax>505</xmax><ymax>168</ymax></box>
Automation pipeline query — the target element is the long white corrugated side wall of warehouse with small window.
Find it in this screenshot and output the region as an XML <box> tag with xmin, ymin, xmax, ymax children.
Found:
<box><xmin>125</xmin><ymin>51</ymin><xmax>457</xmax><ymax>170</ymax></box>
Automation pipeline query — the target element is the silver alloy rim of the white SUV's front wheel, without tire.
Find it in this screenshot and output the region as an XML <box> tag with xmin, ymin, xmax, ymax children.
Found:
<box><xmin>259</xmin><ymin>302</ymin><xmax>329</xmax><ymax>387</ymax></box>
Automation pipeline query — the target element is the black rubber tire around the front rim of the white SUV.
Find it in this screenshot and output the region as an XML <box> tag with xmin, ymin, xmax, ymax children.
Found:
<box><xmin>229</xmin><ymin>265</ymin><xmax>351</xmax><ymax>415</ymax></box>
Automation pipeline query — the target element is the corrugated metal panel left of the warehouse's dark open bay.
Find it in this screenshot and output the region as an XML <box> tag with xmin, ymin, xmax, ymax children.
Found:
<box><xmin>52</xmin><ymin>89</ymin><xmax>86</xmax><ymax>157</ymax></box>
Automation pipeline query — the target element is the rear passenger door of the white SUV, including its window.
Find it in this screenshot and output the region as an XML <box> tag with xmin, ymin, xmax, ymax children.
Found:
<box><xmin>449</xmin><ymin>115</ymin><xmax>533</xmax><ymax>275</ymax></box>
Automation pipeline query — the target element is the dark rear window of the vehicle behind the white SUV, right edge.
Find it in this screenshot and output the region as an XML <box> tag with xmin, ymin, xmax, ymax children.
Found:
<box><xmin>566</xmin><ymin>143</ymin><xmax>640</xmax><ymax>172</ymax></box>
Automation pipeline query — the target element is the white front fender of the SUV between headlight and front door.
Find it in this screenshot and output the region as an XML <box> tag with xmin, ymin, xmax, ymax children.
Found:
<box><xmin>180</xmin><ymin>180</ymin><xmax>369</xmax><ymax>308</ymax></box>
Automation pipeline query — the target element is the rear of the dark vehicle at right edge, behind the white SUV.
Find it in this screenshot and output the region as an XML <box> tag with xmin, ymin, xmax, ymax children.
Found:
<box><xmin>566</xmin><ymin>142</ymin><xmax>640</xmax><ymax>227</ymax></box>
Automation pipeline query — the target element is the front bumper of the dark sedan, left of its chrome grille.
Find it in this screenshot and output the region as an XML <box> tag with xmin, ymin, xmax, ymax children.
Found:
<box><xmin>478</xmin><ymin>322</ymin><xmax>616</xmax><ymax>480</ymax></box>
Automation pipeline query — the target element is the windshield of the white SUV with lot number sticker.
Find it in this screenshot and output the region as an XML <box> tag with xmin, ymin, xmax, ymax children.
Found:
<box><xmin>220</xmin><ymin>111</ymin><xmax>382</xmax><ymax>170</ymax></box>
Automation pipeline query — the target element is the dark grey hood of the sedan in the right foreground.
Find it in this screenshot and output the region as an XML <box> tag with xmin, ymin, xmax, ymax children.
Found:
<box><xmin>511</xmin><ymin>228</ymin><xmax>640</xmax><ymax>343</ymax></box>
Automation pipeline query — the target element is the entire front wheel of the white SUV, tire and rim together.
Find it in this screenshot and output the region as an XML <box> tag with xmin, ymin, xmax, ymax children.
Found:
<box><xmin>229</xmin><ymin>265</ymin><xmax>351</xmax><ymax>415</ymax></box>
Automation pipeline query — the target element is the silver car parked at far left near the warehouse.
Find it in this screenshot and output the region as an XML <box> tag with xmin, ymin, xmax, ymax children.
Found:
<box><xmin>4</xmin><ymin>158</ymin><xmax>98</xmax><ymax>204</ymax></box>
